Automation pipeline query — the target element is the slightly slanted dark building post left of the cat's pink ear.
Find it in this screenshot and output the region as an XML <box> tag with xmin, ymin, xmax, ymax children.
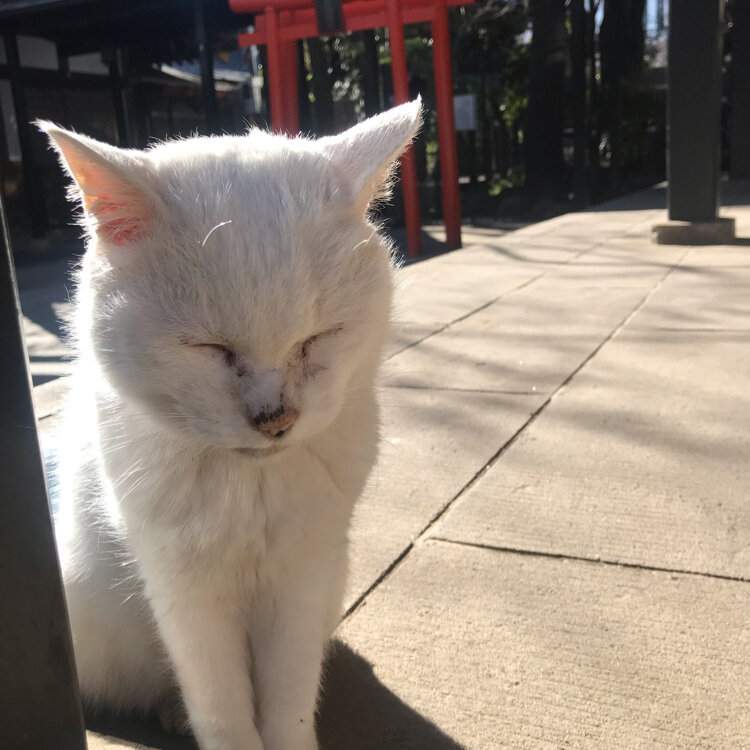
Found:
<box><xmin>5</xmin><ymin>33</ymin><xmax>47</xmax><ymax>237</ymax></box>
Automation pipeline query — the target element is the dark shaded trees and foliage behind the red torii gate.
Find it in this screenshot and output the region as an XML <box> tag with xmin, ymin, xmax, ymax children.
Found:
<box><xmin>296</xmin><ymin>0</ymin><xmax>665</xmax><ymax>214</ymax></box>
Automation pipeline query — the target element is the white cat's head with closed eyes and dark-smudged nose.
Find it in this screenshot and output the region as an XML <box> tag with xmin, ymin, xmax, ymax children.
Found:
<box><xmin>40</xmin><ymin>101</ymin><xmax>420</xmax><ymax>455</ymax></box>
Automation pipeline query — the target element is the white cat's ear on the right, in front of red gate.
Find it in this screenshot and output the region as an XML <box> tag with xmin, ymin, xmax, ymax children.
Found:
<box><xmin>319</xmin><ymin>97</ymin><xmax>422</xmax><ymax>211</ymax></box>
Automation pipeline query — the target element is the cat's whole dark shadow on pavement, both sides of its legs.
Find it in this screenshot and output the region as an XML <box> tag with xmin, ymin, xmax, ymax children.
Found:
<box><xmin>86</xmin><ymin>641</ymin><xmax>463</xmax><ymax>750</ymax></box>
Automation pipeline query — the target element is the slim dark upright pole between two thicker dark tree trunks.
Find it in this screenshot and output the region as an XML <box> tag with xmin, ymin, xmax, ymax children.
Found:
<box><xmin>570</xmin><ymin>0</ymin><xmax>589</xmax><ymax>207</ymax></box>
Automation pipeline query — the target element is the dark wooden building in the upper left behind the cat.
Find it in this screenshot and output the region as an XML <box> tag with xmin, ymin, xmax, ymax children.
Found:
<box><xmin>0</xmin><ymin>0</ymin><xmax>260</xmax><ymax>247</ymax></box>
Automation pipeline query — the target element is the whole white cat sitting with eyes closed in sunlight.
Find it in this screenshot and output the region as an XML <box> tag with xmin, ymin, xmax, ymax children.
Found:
<box><xmin>40</xmin><ymin>101</ymin><xmax>420</xmax><ymax>750</ymax></box>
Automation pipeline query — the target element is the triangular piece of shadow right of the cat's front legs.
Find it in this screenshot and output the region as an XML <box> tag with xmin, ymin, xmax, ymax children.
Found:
<box><xmin>318</xmin><ymin>641</ymin><xmax>463</xmax><ymax>750</ymax></box>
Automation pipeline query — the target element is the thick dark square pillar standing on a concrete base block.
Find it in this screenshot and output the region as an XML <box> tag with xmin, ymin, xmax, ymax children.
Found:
<box><xmin>667</xmin><ymin>0</ymin><xmax>724</xmax><ymax>222</ymax></box>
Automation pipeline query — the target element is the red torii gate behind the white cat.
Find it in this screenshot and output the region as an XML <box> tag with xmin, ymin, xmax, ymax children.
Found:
<box><xmin>229</xmin><ymin>0</ymin><xmax>474</xmax><ymax>256</ymax></box>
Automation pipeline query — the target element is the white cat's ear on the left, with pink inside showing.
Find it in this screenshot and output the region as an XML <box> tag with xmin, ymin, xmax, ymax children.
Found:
<box><xmin>37</xmin><ymin>121</ymin><xmax>157</xmax><ymax>247</ymax></box>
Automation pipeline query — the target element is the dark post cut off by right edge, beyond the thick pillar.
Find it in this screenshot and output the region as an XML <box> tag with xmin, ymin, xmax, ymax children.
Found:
<box><xmin>729</xmin><ymin>0</ymin><xmax>750</xmax><ymax>180</ymax></box>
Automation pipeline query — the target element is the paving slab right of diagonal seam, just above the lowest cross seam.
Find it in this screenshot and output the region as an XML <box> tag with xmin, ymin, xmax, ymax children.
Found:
<box><xmin>434</xmin><ymin>331</ymin><xmax>750</xmax><ymax>580</ymax></box>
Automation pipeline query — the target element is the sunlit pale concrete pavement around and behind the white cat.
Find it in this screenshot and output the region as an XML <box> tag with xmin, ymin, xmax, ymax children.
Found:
<box><xmin>25</xmin><ymin>186</ymin><xmax>750</xmax><ymax>750</ymax></box>
